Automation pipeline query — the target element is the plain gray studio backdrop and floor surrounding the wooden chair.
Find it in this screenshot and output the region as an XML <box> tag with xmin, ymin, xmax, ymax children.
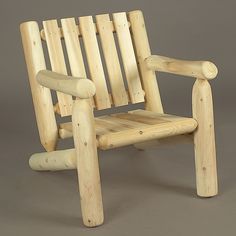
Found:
<box><xmin>0</xmin><ymin>0</ymin><xmax>236</xmax><ymax>236</ymax></box>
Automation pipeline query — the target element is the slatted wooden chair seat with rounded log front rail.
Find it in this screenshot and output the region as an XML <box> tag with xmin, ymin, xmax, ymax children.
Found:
<box><xmin>59</xmin><ymin>110</ymin><xmax>197</xmax><ymax>150</ymax></box>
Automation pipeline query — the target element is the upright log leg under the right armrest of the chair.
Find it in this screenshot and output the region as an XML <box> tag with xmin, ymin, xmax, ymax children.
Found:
<box><xmin>193</xmin><ymin>79</ymin><xmax>218</xmax><ymax>197</ymax></box>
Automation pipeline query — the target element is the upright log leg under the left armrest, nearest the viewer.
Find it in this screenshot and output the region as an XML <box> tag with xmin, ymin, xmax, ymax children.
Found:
<box><xmin>72</xmin><ymin>99</ymin><xmax>104</xmax><ymax>227</ymax></box>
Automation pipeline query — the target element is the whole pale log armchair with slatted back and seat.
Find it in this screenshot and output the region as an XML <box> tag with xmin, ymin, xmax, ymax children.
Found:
<box><xmin>20</xmin><ymin>11</ymin><xmax>217</xmax><ymax>227</ymax></box>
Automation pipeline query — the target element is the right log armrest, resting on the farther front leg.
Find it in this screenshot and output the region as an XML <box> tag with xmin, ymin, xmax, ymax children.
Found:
<box><xmin>145</xmin><ymin>55</ymin><xmax>218</xmax><ymax>80</ymax></box>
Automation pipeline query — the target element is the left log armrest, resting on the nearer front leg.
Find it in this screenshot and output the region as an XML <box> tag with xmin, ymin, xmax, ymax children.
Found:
<box><xmin>36</xmin><ymin>70</ymin><xmax>96</xmax><ymax>99</ymax></box>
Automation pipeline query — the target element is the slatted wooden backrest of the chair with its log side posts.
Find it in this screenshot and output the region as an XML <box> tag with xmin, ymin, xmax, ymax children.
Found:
<box><xmin>21</xmin><ymin>11</ymin><xmax>162</xmax><ymax>119</ymax></box>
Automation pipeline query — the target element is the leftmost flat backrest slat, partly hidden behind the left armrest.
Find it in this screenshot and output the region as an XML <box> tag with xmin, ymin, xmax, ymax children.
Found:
<box><xmin>43</xmin><ymin>20</ymin><xmax>73</xmax><ymax>116</ymax></box>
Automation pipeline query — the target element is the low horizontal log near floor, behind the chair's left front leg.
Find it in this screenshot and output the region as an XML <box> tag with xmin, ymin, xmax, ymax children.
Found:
<box><xmin>29</xmin><ymin>149</ymin><xmax>77</xmax><ymax>171</ymax></box>
